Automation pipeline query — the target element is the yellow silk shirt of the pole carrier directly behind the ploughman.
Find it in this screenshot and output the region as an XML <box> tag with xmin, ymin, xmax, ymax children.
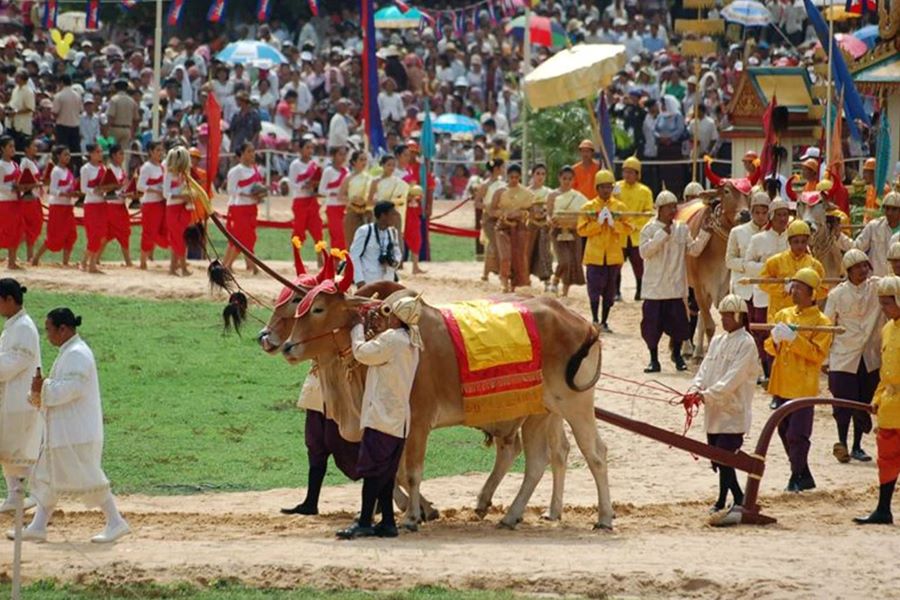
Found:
<box><xmin>765</xmin><ymin>304</ymin><xmax>832</xmax><ymax>399</ymax></box>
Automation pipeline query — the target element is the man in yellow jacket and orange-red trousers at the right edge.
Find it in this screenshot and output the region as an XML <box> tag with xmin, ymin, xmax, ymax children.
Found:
<box><xmin>853</xmin><ymin>275</ymin><xmax>900</xmax><ymax>525</ymax></box>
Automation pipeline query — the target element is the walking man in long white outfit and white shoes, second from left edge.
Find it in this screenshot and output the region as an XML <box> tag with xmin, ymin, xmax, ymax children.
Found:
<box><xmin>14</xmin><ymin>308</ymin><xmax>131</xmax><ymax>544</ymax></box>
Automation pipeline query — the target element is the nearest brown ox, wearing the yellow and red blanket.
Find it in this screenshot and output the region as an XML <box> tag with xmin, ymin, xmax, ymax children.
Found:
<box><xmin>284</xmin><ymin>291</ymin><xmax>613</xmax><ymax>529</ymax></box>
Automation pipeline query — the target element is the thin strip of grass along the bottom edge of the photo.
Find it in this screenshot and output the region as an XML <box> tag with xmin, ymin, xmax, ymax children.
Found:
<box><xmin>10</xmin><ymin>580</ymin><xmax>529</xmax><ymax>600</ymax></box>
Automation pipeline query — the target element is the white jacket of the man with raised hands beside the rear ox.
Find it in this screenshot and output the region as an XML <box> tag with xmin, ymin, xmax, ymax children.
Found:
<box><xmin>640</xmin><ymin>219</ymin><xmax>710</xmax><ymax>300</ymax></box>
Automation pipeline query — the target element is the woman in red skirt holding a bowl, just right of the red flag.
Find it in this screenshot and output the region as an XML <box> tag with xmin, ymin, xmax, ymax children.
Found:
<box><xmin>223</xmin><ymin>142</ymin><xmax>265</xmax><ymax>274</ymax></box>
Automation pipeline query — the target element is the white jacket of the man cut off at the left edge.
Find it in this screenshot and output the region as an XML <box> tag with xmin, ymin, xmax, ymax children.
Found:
<box><xmin>0</xmin><ymin>309</ymin><xmax>43</xmax><ymax>466</ymax></box>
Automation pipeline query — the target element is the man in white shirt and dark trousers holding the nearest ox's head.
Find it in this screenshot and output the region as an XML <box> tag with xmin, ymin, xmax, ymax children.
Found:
<box><xmin>337</xmin><ymin>290</ymin><xmax>423</xmax><ymax>539</ymax></box>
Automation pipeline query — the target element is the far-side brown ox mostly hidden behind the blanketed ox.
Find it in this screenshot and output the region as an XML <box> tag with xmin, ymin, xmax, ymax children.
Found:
<box><xmin>257</xmin><ymin>282</ymin><xmax>569</xmax><ymax>520</ymax></box>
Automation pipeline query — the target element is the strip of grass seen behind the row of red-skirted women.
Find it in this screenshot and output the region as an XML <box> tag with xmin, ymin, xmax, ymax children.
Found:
<box><xmin>10</xmin><ymin>216</ymin><xmax>475</xmax><ymax>263</ymax></box>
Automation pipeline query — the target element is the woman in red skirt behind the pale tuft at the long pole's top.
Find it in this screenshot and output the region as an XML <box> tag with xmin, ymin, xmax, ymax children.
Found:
<box><xmin>163</xmin><ymin>146</ymin><xmax>191</xmax><ymax>277</ymax></box>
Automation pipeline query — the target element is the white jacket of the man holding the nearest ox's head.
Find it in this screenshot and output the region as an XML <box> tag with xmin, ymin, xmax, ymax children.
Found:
<box><xmin>350</xmin><ymin>325</ymin><xmax>419</xmax><ymax>438</ymax></box>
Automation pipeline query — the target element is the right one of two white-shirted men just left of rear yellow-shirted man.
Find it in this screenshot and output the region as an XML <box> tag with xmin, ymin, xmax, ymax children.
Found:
<box><xmin>744</xmin><ymin>196</ymin><xmax>791</xmax><ymax>383</ymax></box>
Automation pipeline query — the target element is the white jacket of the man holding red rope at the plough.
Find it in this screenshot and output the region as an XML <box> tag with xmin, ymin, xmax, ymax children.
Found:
<box><xmin>691</xmin><ymin>327</ymin><xmax>760</xmax><ymax>433</ymax></box>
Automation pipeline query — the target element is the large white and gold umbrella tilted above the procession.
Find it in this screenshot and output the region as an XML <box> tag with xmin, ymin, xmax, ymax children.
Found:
<box><xmin>525</xmin><ymin>44</ymin><xmax>626</xmax><ymax>109</ymax></box>
